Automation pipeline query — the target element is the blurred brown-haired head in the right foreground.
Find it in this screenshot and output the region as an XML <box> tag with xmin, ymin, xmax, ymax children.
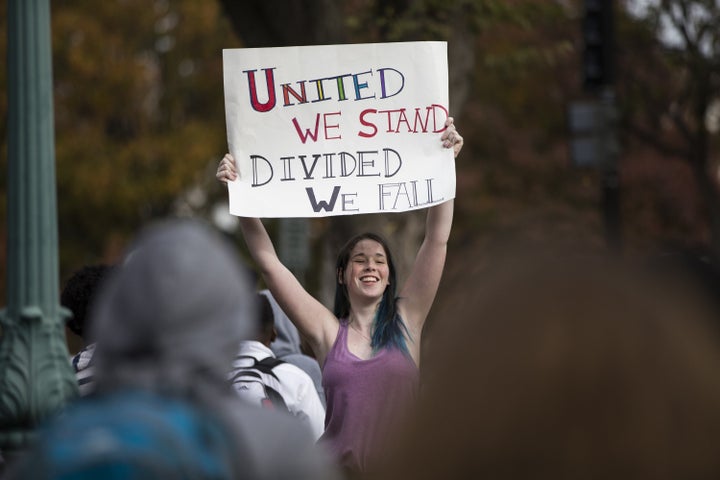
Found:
<box><xmin>374</xmin><ymin>247</ymin><xmax>720</xmax><ymax>480</ymax></box>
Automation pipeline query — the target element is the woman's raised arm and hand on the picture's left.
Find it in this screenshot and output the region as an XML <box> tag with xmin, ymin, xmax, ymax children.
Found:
<box><xmin>216</xmin><ymin>154</ymin><xmax>337</xmax><ymax>365</ymax></box>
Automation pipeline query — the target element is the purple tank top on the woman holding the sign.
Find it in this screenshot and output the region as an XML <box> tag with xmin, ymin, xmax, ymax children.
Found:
<box><xmin>320</xmin><ymin>320</ymin><xmax>418</xmax><ymax>471</ymax></box>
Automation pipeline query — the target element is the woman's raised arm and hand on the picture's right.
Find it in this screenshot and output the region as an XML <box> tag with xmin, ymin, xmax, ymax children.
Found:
<box><xmin>398</xmin><ymin>117</ymin><xmax>463</xmax><ymax>340</ymax></box>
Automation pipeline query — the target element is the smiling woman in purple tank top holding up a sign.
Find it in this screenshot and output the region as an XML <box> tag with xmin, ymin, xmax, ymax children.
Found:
<box><xmin>216</xmin><ymin>118</ymin><xmax>463</xmax><ymax>472</ymax></box>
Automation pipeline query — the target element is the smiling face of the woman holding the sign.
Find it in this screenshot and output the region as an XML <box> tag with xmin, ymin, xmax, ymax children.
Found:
<box><xmin>339</xmin><ymin>239</ymin><xmax>390</xmax><ymax>298</ymax></box>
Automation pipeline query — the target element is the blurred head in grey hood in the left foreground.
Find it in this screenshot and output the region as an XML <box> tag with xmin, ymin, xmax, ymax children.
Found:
<box><xmin>90</xmin><ymin>220</ymin><xmax>257</xmax><ymax>396</ymax></box>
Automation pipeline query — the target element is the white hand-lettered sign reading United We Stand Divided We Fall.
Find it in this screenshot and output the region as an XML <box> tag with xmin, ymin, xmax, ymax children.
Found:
<box><xmin>223</xmin><ymin>42</ymin><xmax>455</xmax><ymax>217</ymax></box>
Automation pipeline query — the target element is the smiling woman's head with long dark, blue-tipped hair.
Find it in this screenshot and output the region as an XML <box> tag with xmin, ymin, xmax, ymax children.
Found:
<box><xmin>334</xmin><ymin>232</ymin><xmax>407</xmax><ymax>351</ymax></box>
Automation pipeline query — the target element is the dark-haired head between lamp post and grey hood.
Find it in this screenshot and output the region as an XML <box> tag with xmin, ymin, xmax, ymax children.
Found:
<box><xmin>60</xmin><ymin>264</ymin><xmax>112</xmax><ymax>338</ymax></box>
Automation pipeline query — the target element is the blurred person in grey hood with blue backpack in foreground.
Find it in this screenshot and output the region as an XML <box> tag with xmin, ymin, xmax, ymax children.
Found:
<box><xmin>11</xmin><ymin>220</ymin><xmax>334</xmax><ymax>480</ymax></box>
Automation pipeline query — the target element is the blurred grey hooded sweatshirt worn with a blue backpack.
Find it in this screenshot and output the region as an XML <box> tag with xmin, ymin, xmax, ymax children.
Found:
<box><xmin>10</xmin><ymin>220</ymin><xmax>337</xmax><ymax>480</ymax></box>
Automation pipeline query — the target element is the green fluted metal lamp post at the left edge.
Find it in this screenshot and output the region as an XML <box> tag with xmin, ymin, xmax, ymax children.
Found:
<box><xmin>0</xmin><ymin>0</ymin><xmax>77</xmax><ymax>460</ymax></box>
